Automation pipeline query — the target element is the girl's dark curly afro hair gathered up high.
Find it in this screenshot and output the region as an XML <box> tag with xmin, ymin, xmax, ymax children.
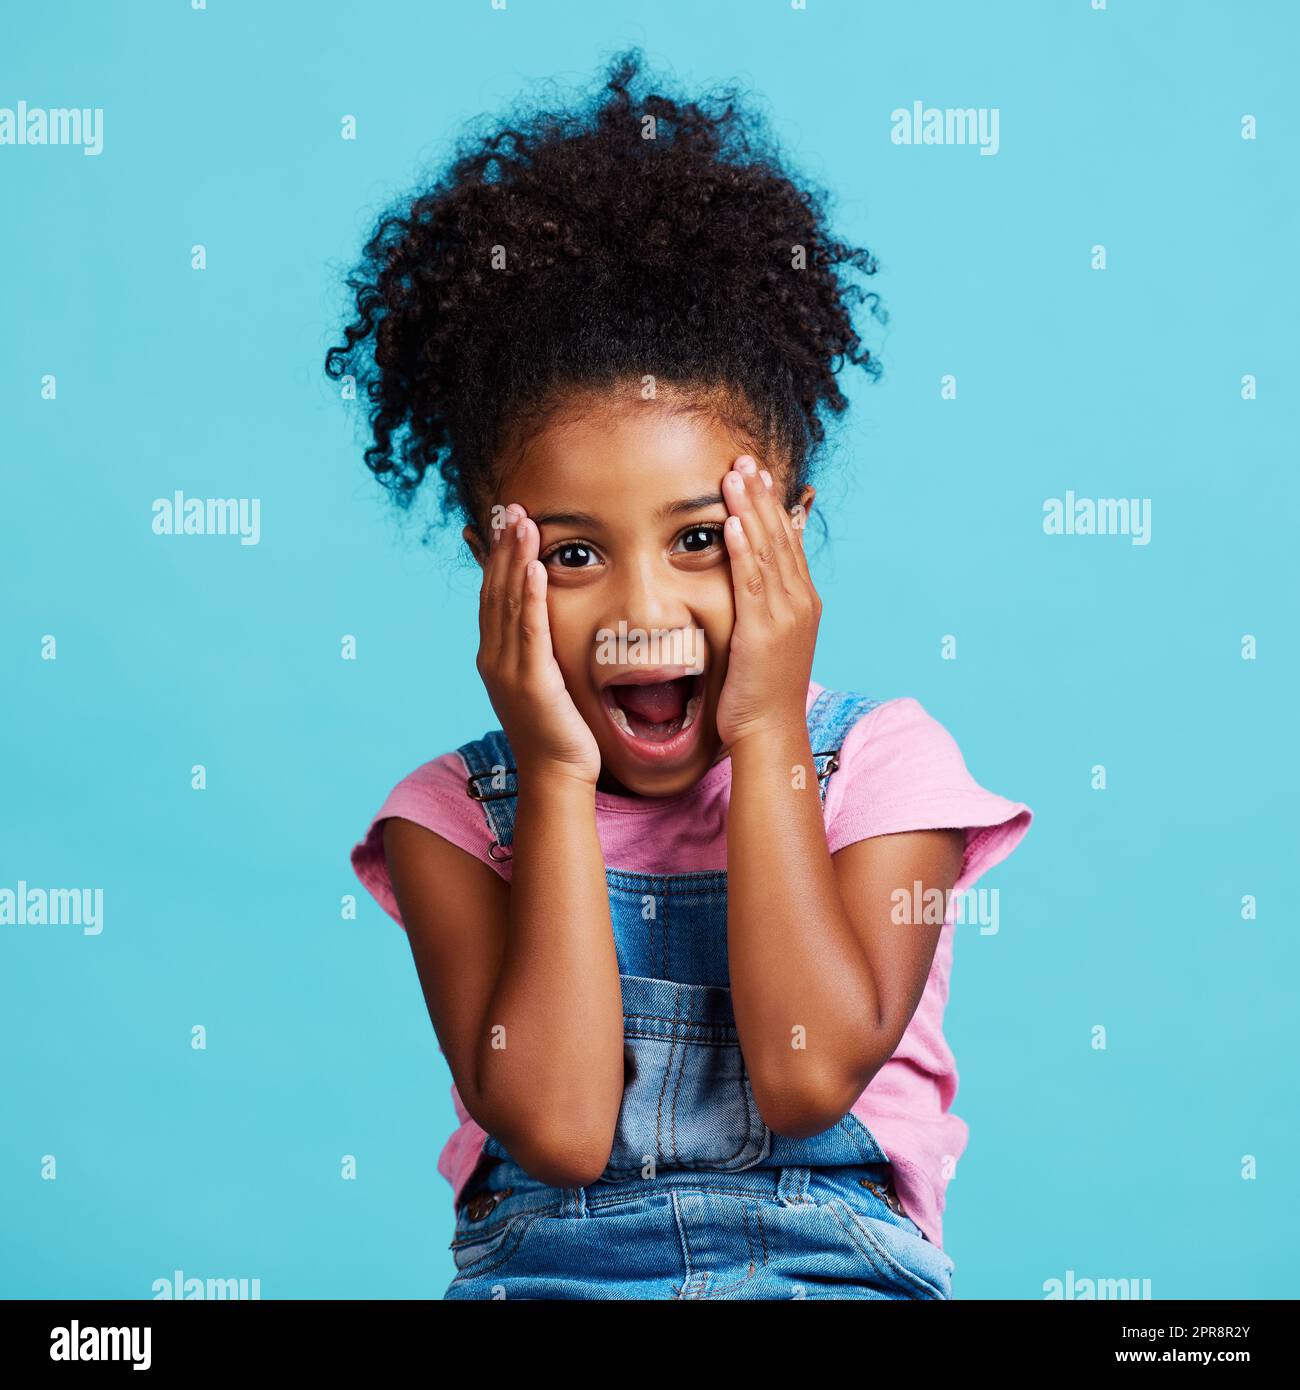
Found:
<box><xmin>325</xmin><ymin>49</ymin><xmax>886</xmax><ymax>538</ymax></box>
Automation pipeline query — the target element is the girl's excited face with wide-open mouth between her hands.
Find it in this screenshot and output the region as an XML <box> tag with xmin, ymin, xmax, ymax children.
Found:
<box><xmin>463</xmin><ymin>400</ymin><xmax>813</xmax><ymax>796</ymax></box>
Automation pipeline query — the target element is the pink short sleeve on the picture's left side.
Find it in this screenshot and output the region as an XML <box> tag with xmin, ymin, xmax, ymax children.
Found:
<box><xmin>352</xmin><ymin>753</ymin><xmax>510</xmax><ymax>931</ymax></box>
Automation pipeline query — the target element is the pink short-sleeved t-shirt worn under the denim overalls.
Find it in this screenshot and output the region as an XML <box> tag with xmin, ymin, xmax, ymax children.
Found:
<box><xmin>352</xmin><ymin>681</ymin><xmax>1032</xmax><ymax>1248</ymax></box>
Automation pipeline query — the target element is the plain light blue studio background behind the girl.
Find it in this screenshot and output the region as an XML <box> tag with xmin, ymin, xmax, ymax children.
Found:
<box><xmin>0</xmin><ymin>0</ymin><xmax>1300</xmax><ymax>1298</ymax></box>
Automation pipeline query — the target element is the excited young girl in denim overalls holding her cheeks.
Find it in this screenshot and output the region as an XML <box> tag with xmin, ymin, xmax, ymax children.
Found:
<box><xmin>328</xmin><ymin>53</ymin><xmax>1030</xmax><ymax>1298</ymax></box>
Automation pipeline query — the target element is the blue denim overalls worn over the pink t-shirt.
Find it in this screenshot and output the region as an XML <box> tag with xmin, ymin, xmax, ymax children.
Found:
<box><xmin>445</xmin><ymin>689</ymin><xmax>954</xmax><ymax>1298</ymax></box>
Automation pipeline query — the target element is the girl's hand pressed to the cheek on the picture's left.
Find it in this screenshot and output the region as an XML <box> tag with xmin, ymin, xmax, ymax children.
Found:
<box><xmin>476</xmin><ymin>502</ymin><xmax>601</xmax><ymax>787</ymax></box>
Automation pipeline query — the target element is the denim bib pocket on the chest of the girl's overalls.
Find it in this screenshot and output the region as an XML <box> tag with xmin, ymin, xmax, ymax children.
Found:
<box><xmin>601</xmin><ymin>976</ymin><xmax>772</xmax><ymax>1182</ymax></box>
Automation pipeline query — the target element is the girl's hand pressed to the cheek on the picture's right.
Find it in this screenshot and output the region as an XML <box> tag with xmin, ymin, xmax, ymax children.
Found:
<box><xmin>717</xmin><ymin>455</ymin><xmax>822</xmax><ymax>748</ymax></box>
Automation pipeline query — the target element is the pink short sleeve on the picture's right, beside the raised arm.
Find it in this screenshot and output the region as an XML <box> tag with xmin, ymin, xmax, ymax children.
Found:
<box><xmin>826</xmin><ymin>699</ymin><xmax>1033</xmax><ymax>887</ymax></box>
